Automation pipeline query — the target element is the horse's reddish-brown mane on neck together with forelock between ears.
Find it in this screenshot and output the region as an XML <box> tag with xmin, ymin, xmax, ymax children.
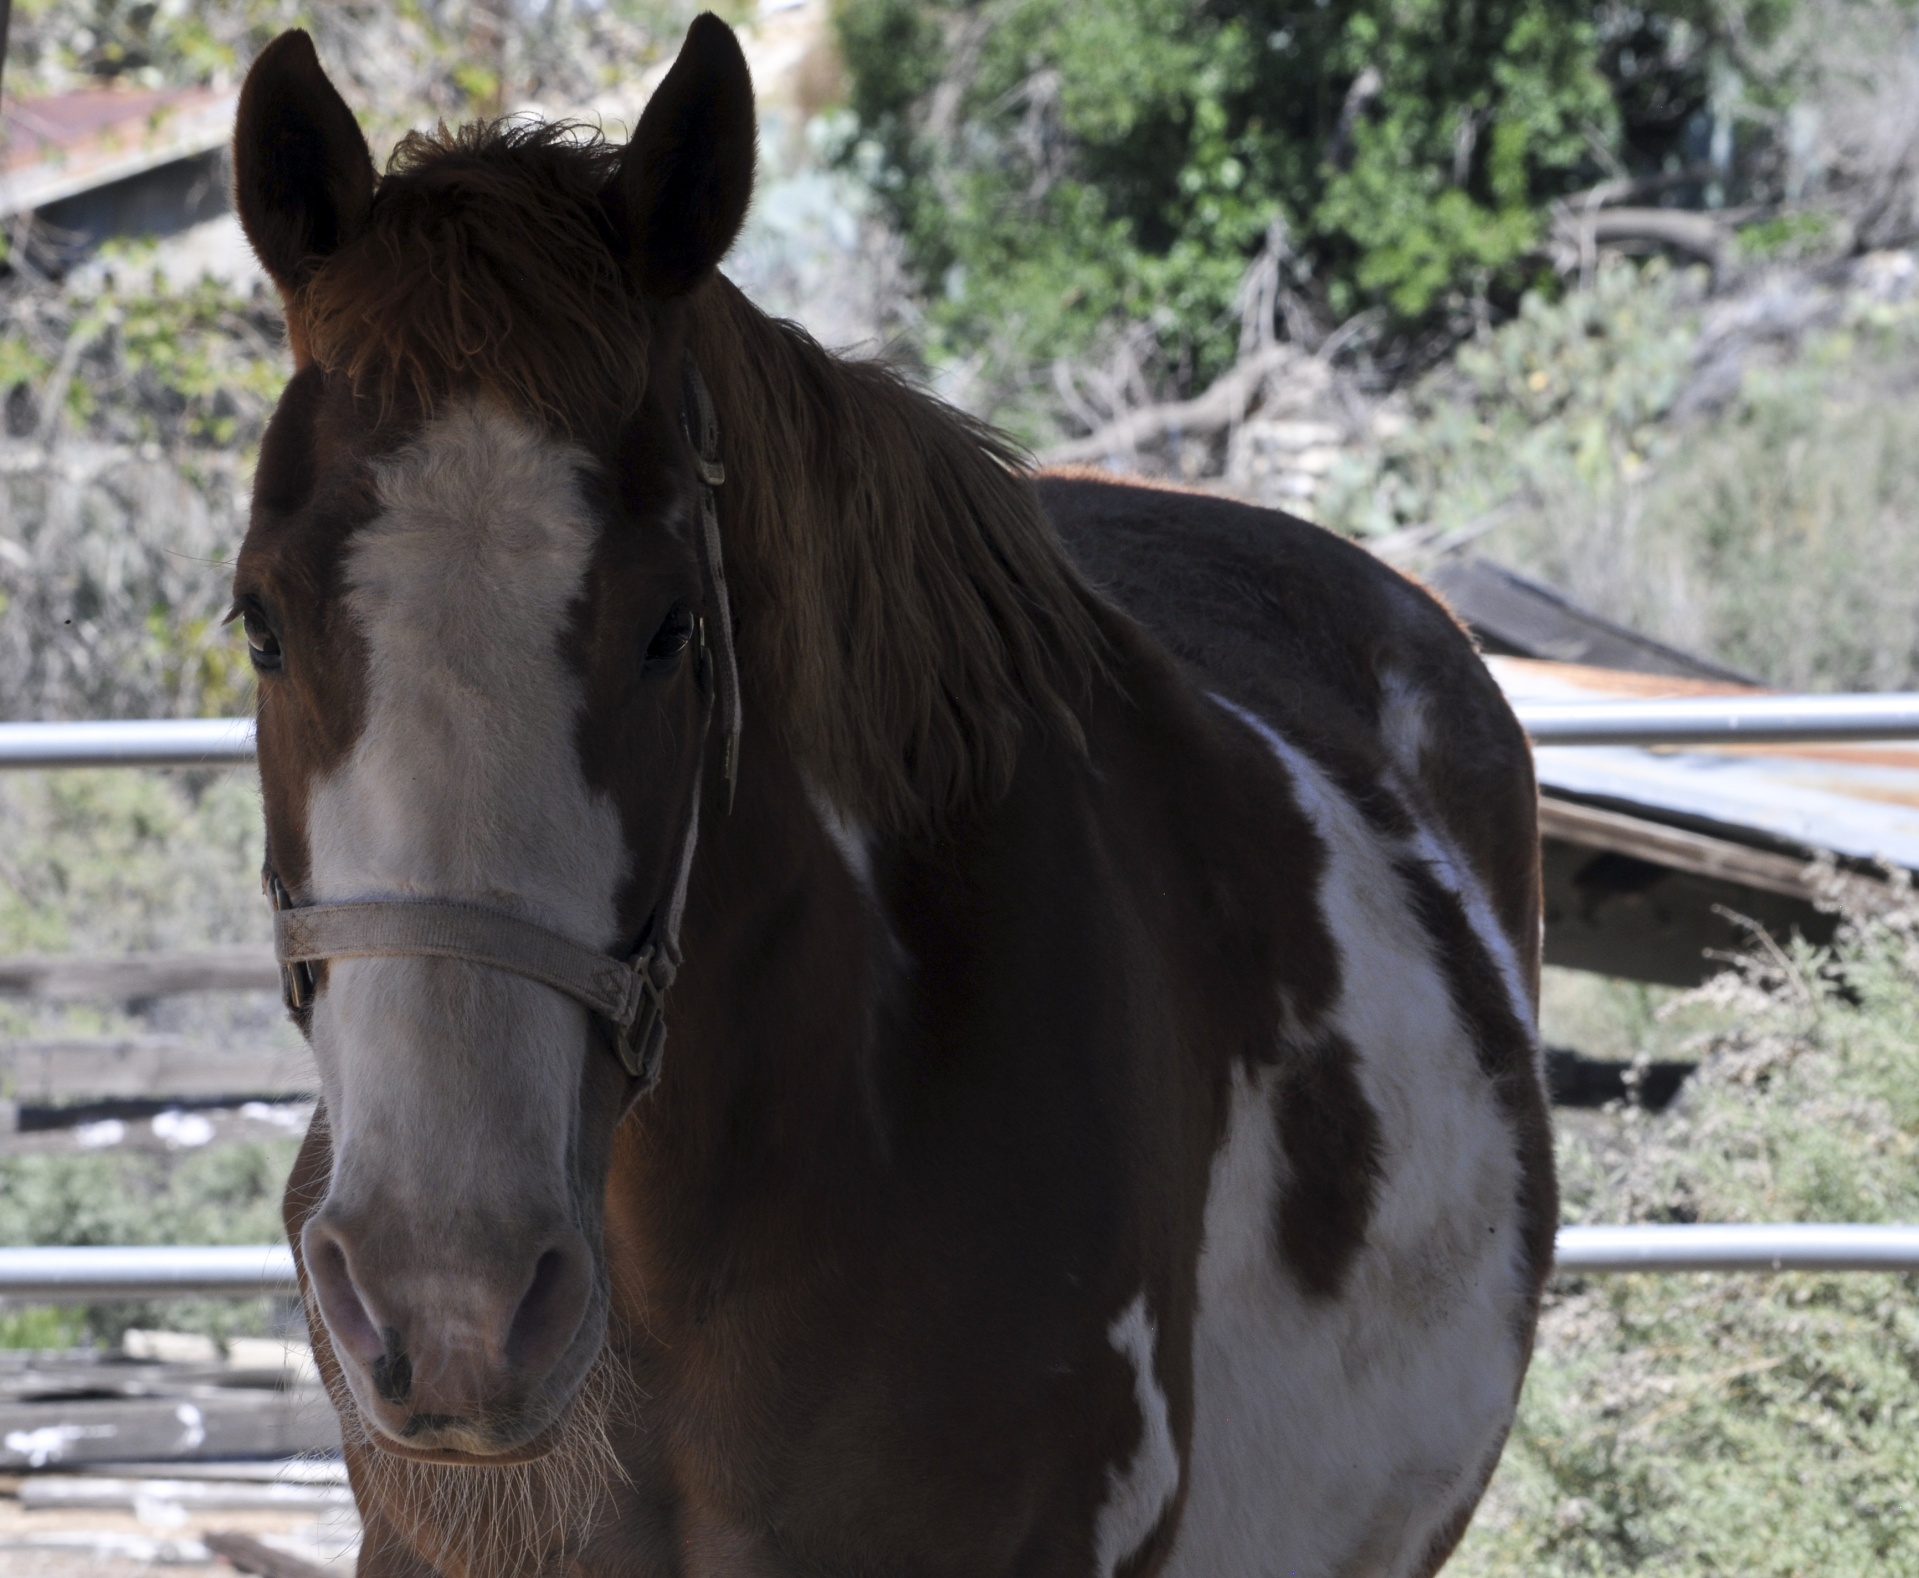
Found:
<box><xmin>290</xmin><ymin>123</ymin><xmax>1105</xmax><ymax>829</ymax></box>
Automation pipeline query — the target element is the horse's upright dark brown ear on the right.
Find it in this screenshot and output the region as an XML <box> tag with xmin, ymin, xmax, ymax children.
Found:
<box><xmin>606</xmin><ymin>12</ymin><xmax>756</xmax><ymax>296</ymax></box>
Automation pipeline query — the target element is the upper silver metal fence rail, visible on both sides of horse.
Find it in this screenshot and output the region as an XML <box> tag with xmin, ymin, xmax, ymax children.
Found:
<box><xmin>0</xmin><ymin>693</ymin><xmax>1919</xmax><ymax>768</ymax></box>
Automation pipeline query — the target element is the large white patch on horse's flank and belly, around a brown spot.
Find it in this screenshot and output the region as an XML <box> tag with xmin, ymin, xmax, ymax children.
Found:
<box><xmin>1167</xmin><ymin>697</ymin><xmax>1528</xmax><ymax>1578</ymax></box>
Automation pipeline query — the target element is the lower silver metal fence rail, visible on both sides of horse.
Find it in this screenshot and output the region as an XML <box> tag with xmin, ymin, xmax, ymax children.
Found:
<box><xmin>0</xmin><ymin>1223</ymin><xmax>1919</xmax><ymax>1303</ymax></box>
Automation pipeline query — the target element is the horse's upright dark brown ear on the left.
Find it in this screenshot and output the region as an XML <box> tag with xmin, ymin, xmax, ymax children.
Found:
<box><xmin>234</xmin><ymin>29</ymin><xmax>374</xmax><ymax>294</ymax></box>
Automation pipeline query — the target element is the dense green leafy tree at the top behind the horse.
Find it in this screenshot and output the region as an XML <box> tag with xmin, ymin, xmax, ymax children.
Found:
<box><xmin>837</xmin><ymin>0</ymin><xmax>1794</xmax><ymax>406</ymax></box>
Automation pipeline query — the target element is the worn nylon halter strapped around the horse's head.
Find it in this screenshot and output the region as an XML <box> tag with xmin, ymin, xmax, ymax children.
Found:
<box><xmin>263</xmin><ymin>361</ymin><xmax>741</xmax><ymax>1094</ymax></box>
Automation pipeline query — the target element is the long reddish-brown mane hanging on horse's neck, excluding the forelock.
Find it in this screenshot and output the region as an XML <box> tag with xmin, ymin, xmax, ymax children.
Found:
<box><xmin>691</xmin><ymin>276</ymin><xmax>1103</xmax><ymax>825</ymax></box>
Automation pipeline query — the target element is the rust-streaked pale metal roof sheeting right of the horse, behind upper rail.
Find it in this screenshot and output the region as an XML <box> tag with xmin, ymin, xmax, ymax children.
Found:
<box><xmin>1487</xmin><ymin>657</ymin><xmax>1919</xmax><ymax>870</ymax></box>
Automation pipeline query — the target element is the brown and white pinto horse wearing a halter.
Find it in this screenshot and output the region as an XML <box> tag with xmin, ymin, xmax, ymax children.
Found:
<box><xmin>234</xmin><ymin>17</ymin><xmax>1554</xmax><ymax>1578</ymax></box>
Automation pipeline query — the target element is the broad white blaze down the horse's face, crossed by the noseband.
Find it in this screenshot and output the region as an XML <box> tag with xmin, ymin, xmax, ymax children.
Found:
<box><xmin>296</xmin><ymin>403</ymin><xmax>626</xmax><ymax>1254</ymax></box>
